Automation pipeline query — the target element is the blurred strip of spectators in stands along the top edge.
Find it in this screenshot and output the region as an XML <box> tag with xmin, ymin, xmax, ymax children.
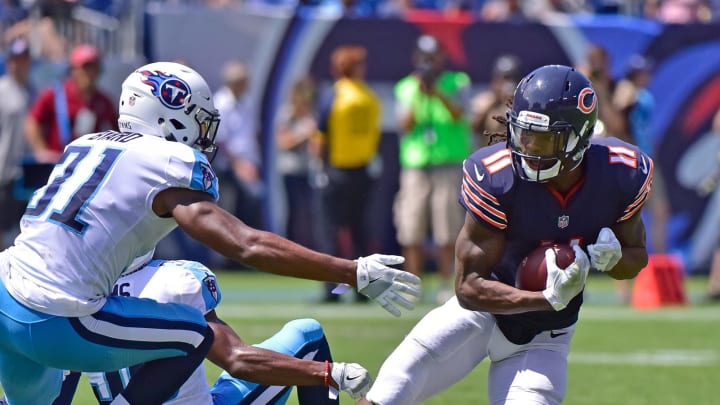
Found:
<box><xmin>0</xmin><ymin>0</ymin><xmax>720</xmax><ymax>33</ymax></box>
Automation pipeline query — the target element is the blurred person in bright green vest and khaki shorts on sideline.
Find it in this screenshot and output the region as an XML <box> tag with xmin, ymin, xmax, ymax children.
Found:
<box><xmin>393</xmin><ymin>35</ymin><xmax>471</xmax><ymax>300</ymax></box>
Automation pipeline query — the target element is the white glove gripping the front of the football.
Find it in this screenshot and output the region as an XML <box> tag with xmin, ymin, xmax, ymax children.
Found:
<box><xmin>543</xmin><ymin>245</ymin><xmax>590</xmax><ymax>311</ymax></box>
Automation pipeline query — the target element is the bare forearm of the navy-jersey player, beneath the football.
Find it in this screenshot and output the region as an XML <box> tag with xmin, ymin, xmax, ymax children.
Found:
<box><xmin>455</xmin><ymin>273</ymin><xmax>553</xmax><ymax>314</ymax></box>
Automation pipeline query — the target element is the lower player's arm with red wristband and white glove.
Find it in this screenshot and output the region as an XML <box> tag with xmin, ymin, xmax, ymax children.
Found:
<box><xmin>205</xmin><ymin>311</ymin><xmax>372</xmax><ymax>398</ymax></box>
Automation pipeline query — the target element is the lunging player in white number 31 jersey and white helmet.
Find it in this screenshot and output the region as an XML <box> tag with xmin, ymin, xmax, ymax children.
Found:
<box><xmin>0</xmin><ymin>62</ymin><xmax>420</xmax><ymax>405</ymax></box>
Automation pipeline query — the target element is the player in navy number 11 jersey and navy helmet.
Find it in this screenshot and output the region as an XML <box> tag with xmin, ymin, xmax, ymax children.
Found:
<box><xmin>358</xmin><ymin>65</ymin><xmax>653</xmax><ymax>405</ymax></box>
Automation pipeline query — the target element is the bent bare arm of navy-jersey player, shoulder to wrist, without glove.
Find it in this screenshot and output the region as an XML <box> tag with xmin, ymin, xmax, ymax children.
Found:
<box><xmin>455</xmin><ymin>215</ymin><xmax>552</xmax><ymax>314</ymax></box>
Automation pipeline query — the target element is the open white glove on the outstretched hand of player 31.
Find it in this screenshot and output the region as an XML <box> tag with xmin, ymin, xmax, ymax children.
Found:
<box><xmin>356</xmin><ymin>254</ymin><xmax>422</xmax><ymax>316</ymax></box>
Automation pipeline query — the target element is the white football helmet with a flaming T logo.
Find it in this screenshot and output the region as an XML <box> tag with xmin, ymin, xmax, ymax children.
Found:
<box><xmin>118</xmin><ymin>62</ymin><xmax>220</xmax><ymax>152</ymax></box>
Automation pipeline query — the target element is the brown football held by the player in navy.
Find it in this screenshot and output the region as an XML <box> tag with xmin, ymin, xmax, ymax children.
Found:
<box><xmin>515</xmin><ymin>244</ymin><xmax>575</xmax><ymax>291</ymax></box>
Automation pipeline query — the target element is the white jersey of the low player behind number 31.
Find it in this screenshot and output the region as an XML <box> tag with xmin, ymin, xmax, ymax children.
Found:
<box><xmin>85</xmin><ymin>260</ymin><xmax>221</xmax><ymax>405</ymax></box>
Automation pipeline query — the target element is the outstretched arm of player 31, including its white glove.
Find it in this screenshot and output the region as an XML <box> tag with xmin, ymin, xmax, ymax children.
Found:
<box><xmin>153</xmin><ymin>188</ymin><xmax>421</xmax><ymax>316</ymax></box>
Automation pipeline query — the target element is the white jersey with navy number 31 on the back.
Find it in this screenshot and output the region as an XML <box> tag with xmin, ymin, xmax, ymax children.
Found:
<box><xmin>0</xmin><ymin>131</ymin><xmax>218</xmax><ymax>317</ymax></box>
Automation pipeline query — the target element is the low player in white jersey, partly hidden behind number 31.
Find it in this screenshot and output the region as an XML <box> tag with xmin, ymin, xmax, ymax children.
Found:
<box><xmin>69</xmin><ymin>260</ymin><xmax>372</xmax><ymax>405</ymax></box>
